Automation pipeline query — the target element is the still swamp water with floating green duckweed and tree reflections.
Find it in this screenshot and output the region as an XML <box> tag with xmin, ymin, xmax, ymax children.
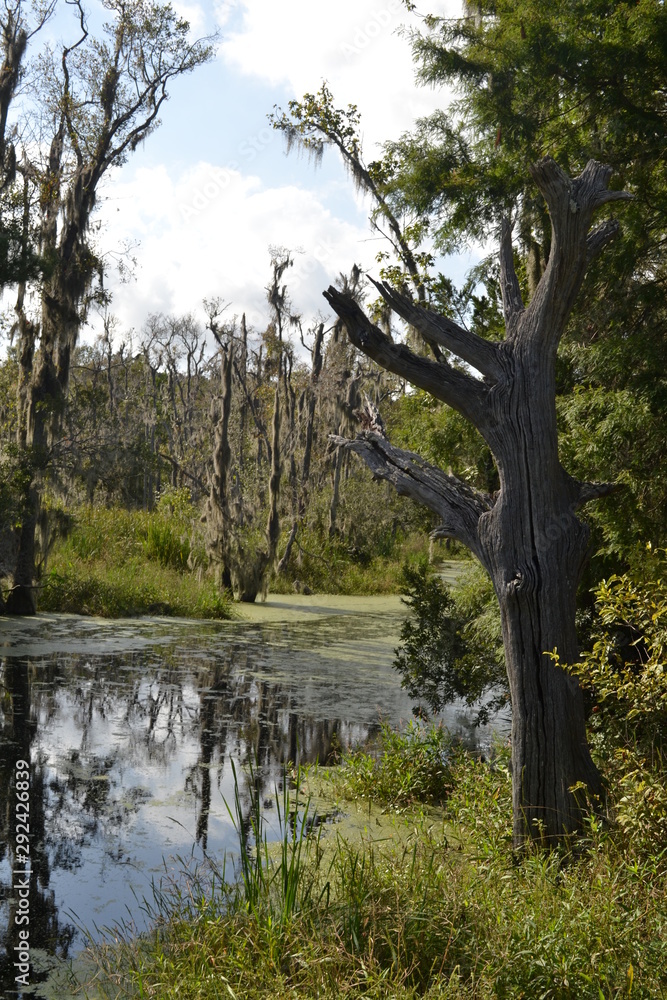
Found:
<box><xmin>0</xmin><ymin>596</ymin><xmax>504</xmax><ymax>997</ymax></box>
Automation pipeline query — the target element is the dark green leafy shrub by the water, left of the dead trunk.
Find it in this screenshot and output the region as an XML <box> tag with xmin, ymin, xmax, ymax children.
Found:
<box><xmin>394</xmin><ymin>563</ymin><xmax>507</xmax><ymax>723</ymax></box>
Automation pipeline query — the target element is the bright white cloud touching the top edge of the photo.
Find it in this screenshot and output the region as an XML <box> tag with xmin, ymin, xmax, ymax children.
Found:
<box><xmin>220</xmin><ymin>0</ymin><xmax>462</xmax><ymax>157</ymax></box>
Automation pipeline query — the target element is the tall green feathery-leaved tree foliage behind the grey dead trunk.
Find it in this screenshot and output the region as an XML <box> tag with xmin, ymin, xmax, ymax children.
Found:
<box><xmin>384</xmin><ymin>0</ymin><xmax>667</xmax><ymax>568</ymax></box>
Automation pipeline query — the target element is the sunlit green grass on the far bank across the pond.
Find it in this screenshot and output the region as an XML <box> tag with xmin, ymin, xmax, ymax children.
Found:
<box><xmin>39</xmin><ymin>503</ymin><xmax>454</xmax><ymax>618</ymax></box>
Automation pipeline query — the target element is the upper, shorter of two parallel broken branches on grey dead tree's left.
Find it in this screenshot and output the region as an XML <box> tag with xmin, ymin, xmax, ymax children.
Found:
<box><xmin>370</xmin><ymin>278</ymin><xmax>503</xmax><ymax>380</ymax></box>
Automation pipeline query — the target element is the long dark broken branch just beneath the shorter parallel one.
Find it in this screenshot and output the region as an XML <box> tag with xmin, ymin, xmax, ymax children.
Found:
<box><xmin>323</xmin><ymin>285</ymin><xmax>488</xmax><ymax>427</ymax></box>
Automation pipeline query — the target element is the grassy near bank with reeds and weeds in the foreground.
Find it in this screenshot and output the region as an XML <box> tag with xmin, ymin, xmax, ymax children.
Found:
<box><xmin>70</xmin><ymin>730</ymin><xmax>667</xmax><ymax>1000</ymax></box>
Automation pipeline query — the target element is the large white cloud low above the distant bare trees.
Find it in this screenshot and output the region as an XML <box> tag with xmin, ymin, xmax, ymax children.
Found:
<box><xmin>95</xmin><ymin>162</ymin><xmax>376</xmax><ymax>329</ymax></box>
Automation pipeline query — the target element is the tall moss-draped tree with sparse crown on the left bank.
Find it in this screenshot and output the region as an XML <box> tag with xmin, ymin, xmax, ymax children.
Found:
<box><xmin>8</xmin><ymin>0</ymin><xmax>213</xmax><ymax>614</ymax></box>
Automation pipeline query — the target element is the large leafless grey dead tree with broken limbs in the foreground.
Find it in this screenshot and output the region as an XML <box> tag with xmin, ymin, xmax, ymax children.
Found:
<box><xmin>325</xmin><ymin>157</ymin><xmax>628</xmax><ymax>846</ymax></box>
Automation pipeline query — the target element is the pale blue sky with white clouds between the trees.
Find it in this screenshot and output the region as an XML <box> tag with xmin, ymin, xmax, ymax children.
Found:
<box><xmin>27</xmin><ymin>0</ymin><xmax>476</xmax><ymax>334</ymax></box>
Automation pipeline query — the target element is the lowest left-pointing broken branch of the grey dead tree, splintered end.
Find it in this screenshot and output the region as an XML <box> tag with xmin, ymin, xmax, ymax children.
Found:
<box><xmin>330</xmin><ymin>431</ymin><xmax>493</xmax><ymax>560</ymax></box>
